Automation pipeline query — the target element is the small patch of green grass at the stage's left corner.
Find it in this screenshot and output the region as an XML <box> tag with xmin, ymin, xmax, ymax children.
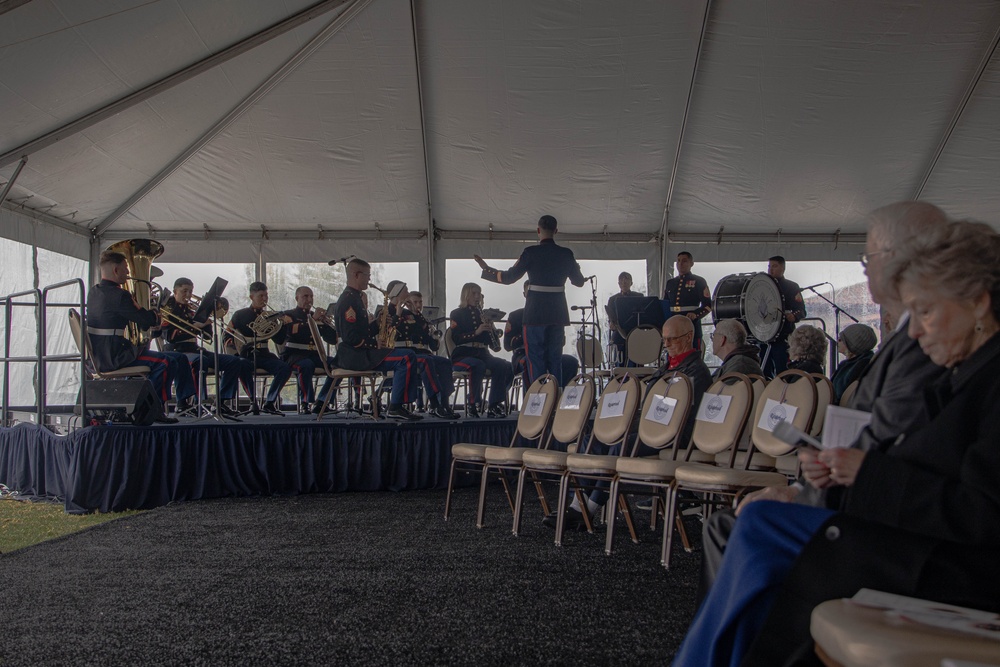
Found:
<box><xmin>0</xmin><ymin>498</ymin><xmax>138</xmax><ymax>554</ymax></box>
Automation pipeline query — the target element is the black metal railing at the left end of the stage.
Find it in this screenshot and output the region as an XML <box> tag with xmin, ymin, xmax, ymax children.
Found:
<box><xmin>0</xmin><ymin>278</ymin><xmax>87</xmax><ymax>426</ymax></box>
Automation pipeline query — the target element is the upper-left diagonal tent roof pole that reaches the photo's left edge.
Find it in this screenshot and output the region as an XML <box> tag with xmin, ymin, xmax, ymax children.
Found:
<box><xmin>0</xmin><ymin>0</ymin><xmax>349</xmax><ymax>167</ymax></box>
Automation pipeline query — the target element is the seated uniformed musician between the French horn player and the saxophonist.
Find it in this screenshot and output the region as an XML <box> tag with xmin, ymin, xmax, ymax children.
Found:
<box><xmin>281</xmin><ymin>285</ymin><xmax>337</xmax><ymax>414</ymax></box>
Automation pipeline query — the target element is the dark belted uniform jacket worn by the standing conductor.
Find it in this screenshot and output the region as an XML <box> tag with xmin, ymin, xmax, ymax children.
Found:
<box><xmin>483</xmin><ymin>239</ymin><xmax>586</xmax><ymax>326</ymax></box>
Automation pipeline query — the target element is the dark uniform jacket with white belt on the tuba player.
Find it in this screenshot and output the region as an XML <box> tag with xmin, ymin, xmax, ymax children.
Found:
<box><xmin>86</xmin><ymin>280</ymin><xmax>158</xmax><ymax>372</ymax></box>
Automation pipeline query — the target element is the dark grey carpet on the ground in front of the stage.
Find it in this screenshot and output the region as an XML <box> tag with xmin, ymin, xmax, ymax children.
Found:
<box><xmin>0</xmin><ymin>487</ymin><xmax>699</xmax><ymax>666</ymax></box>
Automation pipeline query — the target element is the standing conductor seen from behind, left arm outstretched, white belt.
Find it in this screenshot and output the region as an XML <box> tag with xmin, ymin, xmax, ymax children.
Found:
<box><xmin>474</xmin><ymin>215</ymin><xmax>587</xmax><ymax>387</ymax></box>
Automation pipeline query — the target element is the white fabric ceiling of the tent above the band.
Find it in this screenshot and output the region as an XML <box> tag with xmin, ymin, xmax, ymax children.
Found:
<box><xmin>0</xmin><ymin>0</ymin><xmax>1000</xmax><ymax>248</ymax></box>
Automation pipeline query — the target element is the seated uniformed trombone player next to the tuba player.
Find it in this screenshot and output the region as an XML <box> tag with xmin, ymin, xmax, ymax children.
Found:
<box><xmin>160</xmin><ymin>278</ymin><xmax>253</xmax><ymax>415</ymax></box>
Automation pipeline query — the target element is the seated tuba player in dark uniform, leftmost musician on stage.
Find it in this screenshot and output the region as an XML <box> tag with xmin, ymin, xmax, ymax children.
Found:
<box><xmin>86</xmin><ymin>252</ymin><xmax>195</xmax><ymax>423</ymax></box>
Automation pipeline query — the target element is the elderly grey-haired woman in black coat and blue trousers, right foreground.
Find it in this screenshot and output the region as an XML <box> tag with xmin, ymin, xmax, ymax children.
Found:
<box><xmin>674</xmin><ymin>222</ymin><xmax>1000</xmax><ymax>667</ymax></box>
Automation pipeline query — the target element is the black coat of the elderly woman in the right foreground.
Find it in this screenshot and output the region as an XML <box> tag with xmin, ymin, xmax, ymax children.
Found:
<box><xmin>744</xmin><ymin>335</ymin><xmax>1000</xmax><ymax>665</ymax></box>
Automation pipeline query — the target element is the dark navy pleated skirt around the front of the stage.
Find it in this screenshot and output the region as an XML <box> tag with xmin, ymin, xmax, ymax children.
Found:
<box><xmin>0</xmin><ymin>415</ymin><xmax>517</xmax><ymax>514</ymax></box>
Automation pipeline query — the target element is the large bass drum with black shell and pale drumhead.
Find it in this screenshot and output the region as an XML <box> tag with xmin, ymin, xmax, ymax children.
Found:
<box><xmin>712</xmin><ymin>273</ymin><xmax>784</xmax><ymax>343</ymax></box>
